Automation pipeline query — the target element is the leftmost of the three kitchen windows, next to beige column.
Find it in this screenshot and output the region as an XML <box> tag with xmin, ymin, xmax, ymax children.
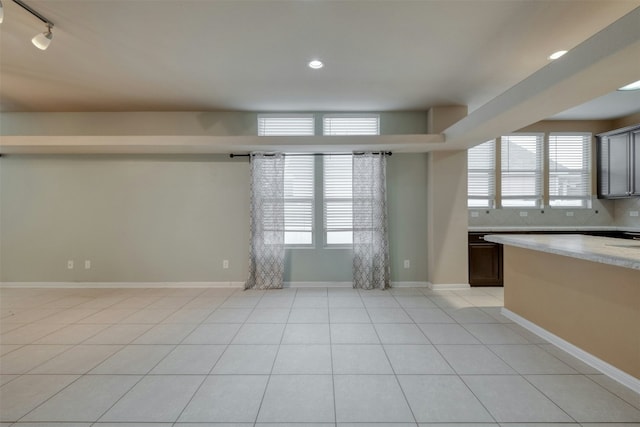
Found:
<box><xmin>467</xmin><ymin>140</ymin><xmax>496</xmax><ymax>209</ymax></box>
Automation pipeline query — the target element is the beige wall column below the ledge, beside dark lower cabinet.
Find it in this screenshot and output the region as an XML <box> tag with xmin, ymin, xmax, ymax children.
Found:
<box><xmin>427</xmin><ymin>150</ymin><xmax>469</xmax><ymax>286</ymax></box>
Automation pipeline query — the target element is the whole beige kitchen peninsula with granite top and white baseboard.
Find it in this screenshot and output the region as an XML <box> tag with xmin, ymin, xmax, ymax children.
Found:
<box><xmin>484</xmin><ymin>234</ymin><xmax>640</xmax><ymax>391</ymax></box>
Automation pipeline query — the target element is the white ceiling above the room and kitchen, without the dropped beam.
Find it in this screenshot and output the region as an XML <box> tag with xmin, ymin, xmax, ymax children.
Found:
<box><xmin>0</xmin><ymin>0</ymin><xmax>640</xmax><ymax>119</ymax></box>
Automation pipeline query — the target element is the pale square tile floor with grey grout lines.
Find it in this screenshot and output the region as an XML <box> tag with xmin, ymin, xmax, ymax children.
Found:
<box><xmin>0</xmin><ymin>288</ymin><xmax>640</xmax><ymax>427</ymax></box>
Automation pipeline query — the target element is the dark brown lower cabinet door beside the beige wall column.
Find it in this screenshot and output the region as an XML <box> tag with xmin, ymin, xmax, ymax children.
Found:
<box><xmin>469</xmin><ymin>242</ymin><xmax>502</xmax><ymax>286</ymax></box>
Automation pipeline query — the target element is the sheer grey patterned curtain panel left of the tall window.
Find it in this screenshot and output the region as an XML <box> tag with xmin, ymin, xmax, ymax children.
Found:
<box><xmin>244</xmin><ymin>154</ymin><xmax>284</xmax><ymax>289</ymax></box>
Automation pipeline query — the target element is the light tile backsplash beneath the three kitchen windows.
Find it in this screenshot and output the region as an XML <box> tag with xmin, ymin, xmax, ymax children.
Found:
<box><xmin>469</xmin><ymin>199</ymin><xmax>616</xmax><ymax>227</ymax></box>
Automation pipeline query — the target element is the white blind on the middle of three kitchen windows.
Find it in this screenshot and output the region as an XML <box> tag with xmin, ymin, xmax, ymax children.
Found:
<box><xmin>501</xmin><ymin>134</ymin><xmax>543</xmax><ymax>208</ymax></box>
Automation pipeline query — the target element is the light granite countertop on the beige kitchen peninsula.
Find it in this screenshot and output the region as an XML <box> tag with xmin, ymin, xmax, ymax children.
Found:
<box><xmin>484</xmin><ymin>234</ymin><xmax>640</xmax><ymax>270</ymax></box>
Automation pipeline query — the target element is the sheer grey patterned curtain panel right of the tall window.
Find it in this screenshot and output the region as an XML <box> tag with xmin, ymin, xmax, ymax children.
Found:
<box><xmin>353</xmin><ymin>153</ymin><xmax>389</xmax><ymax>289</ymax></box>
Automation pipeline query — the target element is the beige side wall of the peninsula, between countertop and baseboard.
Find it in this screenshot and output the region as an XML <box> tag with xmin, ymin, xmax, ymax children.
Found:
<box><xmin>504</xmin><ymin>246</ymin><xmax>640</xmax><ymax>378</ymax></box>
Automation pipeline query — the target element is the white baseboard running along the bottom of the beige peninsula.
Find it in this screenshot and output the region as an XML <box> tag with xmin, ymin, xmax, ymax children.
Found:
<box><xmin>501</xmin><ymin>307</ymin><xmax>640</xmax><ymax>393</ymax></box>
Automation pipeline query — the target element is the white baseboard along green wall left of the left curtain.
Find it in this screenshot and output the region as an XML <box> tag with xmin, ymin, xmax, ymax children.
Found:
<box><xmin>0</xmin><ymin>282</ymin><xmax>244</xmax><ymax>289</ymax></box>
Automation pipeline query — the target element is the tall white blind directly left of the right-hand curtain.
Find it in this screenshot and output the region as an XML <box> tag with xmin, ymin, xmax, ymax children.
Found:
<box><xmin>323</xmin><ymin>155</ymin><xmax>353</xmax><ymax>245</ymax></box>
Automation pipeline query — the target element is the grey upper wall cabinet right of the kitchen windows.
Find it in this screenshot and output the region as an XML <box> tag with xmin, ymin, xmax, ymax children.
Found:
<box><xmin>597</xmin><ymin>126</ymin><xmax>640</xmax><ymax>199</ymax></box>
